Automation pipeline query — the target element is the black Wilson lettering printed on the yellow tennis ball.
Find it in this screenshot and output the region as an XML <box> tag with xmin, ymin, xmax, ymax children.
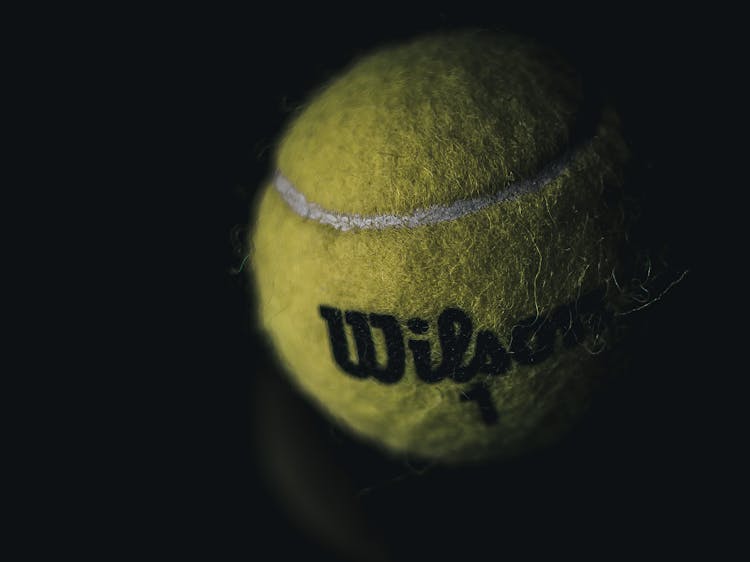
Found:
<box><xmin>319</xmin><ymin>290</ymin><xmax>608</xmax><ymax>384</ymax></box>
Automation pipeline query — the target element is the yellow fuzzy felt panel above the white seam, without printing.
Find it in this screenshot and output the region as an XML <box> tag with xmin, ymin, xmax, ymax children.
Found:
<box><xmin>278</xmin><ymin>32</ymin><xmax>582</xmax><ymax>214</ymax></box>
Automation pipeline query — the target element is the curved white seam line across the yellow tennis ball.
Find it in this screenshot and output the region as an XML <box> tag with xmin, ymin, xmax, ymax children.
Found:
<box><xmin>273</xmin><ymin>154</ymin><xmax>571</xmax><ymax>231</ymax></box>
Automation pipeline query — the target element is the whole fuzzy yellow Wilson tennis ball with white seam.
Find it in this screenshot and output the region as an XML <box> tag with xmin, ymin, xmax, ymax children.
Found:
<box><xmin>250</xmin><ymin>31</ymin><xmax>627</xmax><ymax>463</ymax></box>
